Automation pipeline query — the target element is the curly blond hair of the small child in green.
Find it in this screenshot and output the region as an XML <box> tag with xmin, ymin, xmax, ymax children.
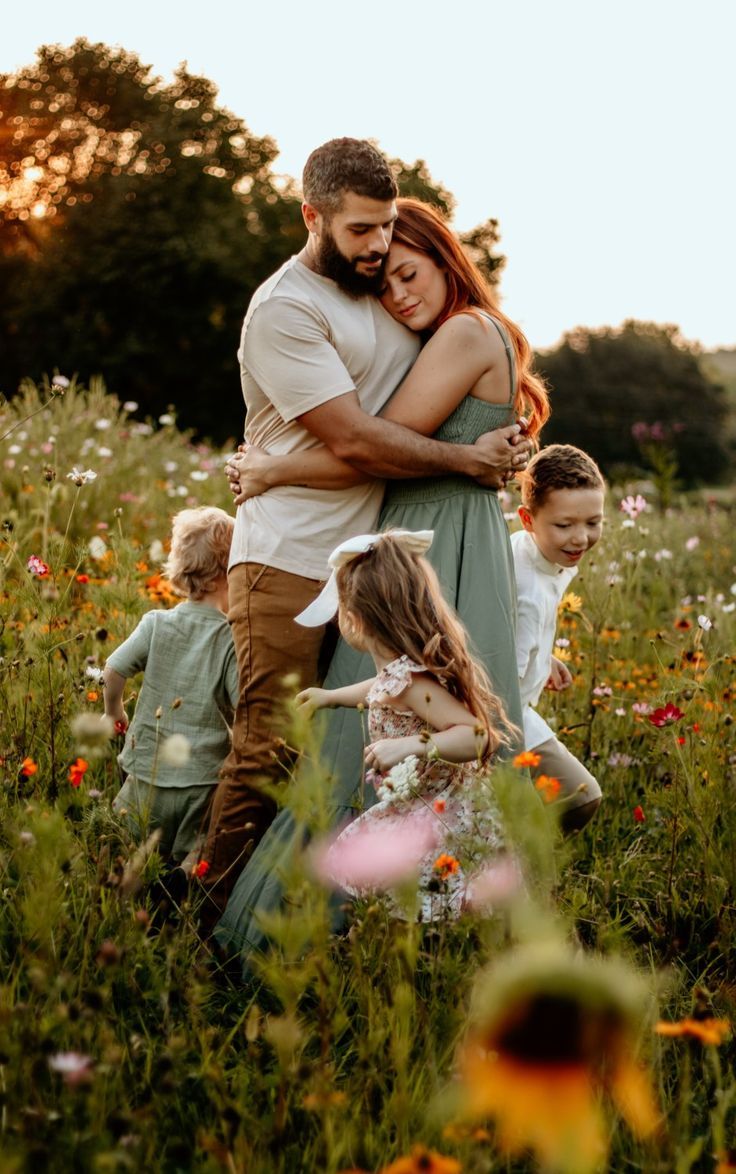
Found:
<box><xmin>163</xmin><ymin>506</ymin><xmax>235</xmax><ymax>599</ymax></box>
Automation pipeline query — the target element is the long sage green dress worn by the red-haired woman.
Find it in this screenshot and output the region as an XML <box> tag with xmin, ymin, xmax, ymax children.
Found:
<box><xmin>215</xmin><ymin>318</ymin><xmax>521</xmax><ymax>973</ymax></box>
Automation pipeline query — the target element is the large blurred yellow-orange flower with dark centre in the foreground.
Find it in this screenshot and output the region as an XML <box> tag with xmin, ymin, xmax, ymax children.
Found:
<box><xmin>459</xmin><ymin>944</ymin><xmax>659</xmax><ymax>1174</ymax></box>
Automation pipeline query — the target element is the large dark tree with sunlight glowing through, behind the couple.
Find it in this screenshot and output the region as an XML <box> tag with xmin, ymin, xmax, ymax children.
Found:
<box><xmin>0</xmin><ymin>40</ymin><xmax>502</xmax><ymax>440</ymax></box>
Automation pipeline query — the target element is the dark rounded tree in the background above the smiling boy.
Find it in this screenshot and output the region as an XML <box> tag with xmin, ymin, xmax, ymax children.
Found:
<box><xmin>536</xmin><ymin>321</ymin><xmax>731</xmax><ymax>484</ymax></box>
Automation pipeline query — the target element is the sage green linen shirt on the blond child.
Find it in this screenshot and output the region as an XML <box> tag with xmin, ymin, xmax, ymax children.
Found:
<box><xmin>106</xmin><ymin>600</ymin><xmax>238</xmax><ymax>787</ymax></box>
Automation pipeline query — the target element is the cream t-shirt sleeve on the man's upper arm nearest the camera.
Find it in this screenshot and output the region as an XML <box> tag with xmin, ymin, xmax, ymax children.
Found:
<box><xmin>241</xmin><ymin>297</ymin><xmax>356</xmax><ymax>423</ymax></box>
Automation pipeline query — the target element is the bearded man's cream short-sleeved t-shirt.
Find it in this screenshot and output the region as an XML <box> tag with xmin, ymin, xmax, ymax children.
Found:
<box><xmin>230</xmin><ymin>257</ymin><xmax>419</xmax><ymax>579</ymax></box>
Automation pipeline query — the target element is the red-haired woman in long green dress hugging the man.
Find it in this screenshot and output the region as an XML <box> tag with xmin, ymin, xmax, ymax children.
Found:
<box><xmin>216</xmin><ymin>198</ymin><xmax>549</xmax><ymax>972</ymax></box>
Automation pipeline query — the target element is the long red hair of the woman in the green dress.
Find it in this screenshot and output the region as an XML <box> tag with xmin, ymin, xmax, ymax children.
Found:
<box><xmin>392</xmin><ymin>197</ymin><xmax>549</xmax><ymax>437</ymax></box>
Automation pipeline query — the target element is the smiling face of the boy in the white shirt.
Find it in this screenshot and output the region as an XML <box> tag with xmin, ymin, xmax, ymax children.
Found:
<box><xmin>519</xmin><ymin>488</ymin><xmax>603</xmax><ymax>567</ymax></box>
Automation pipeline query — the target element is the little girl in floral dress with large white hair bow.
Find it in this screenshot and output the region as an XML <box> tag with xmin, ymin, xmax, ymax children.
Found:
<box><xmin>297</xmin><ymin>531</ymin><xmax>511</xmax><ymax>920</ymax></box>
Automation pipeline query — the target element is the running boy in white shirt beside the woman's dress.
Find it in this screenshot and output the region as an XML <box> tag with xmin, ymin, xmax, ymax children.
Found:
<box><xmin>511</xmin><ymin>444</ymin><xmax>606</xmax><ymax>831</ymax></box>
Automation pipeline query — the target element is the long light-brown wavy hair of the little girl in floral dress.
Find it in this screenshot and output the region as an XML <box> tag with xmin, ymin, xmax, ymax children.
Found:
<box><xmin>337</xmin><ymin>529</ymin><xmax>516</xmax><ymax>758</ymax></box>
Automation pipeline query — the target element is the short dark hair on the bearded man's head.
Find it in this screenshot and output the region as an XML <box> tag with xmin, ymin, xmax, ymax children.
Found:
<box><xmin>302</xmin><ymin>139</ymin><xmax>399</xmax><ymax>216</ymax></box>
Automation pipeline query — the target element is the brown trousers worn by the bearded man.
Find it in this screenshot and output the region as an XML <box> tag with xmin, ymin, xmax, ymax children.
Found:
<box><xmin>202</xmin><ymin>562</ymin><xmax>324</xmax><ymax>930</ymax></box>
